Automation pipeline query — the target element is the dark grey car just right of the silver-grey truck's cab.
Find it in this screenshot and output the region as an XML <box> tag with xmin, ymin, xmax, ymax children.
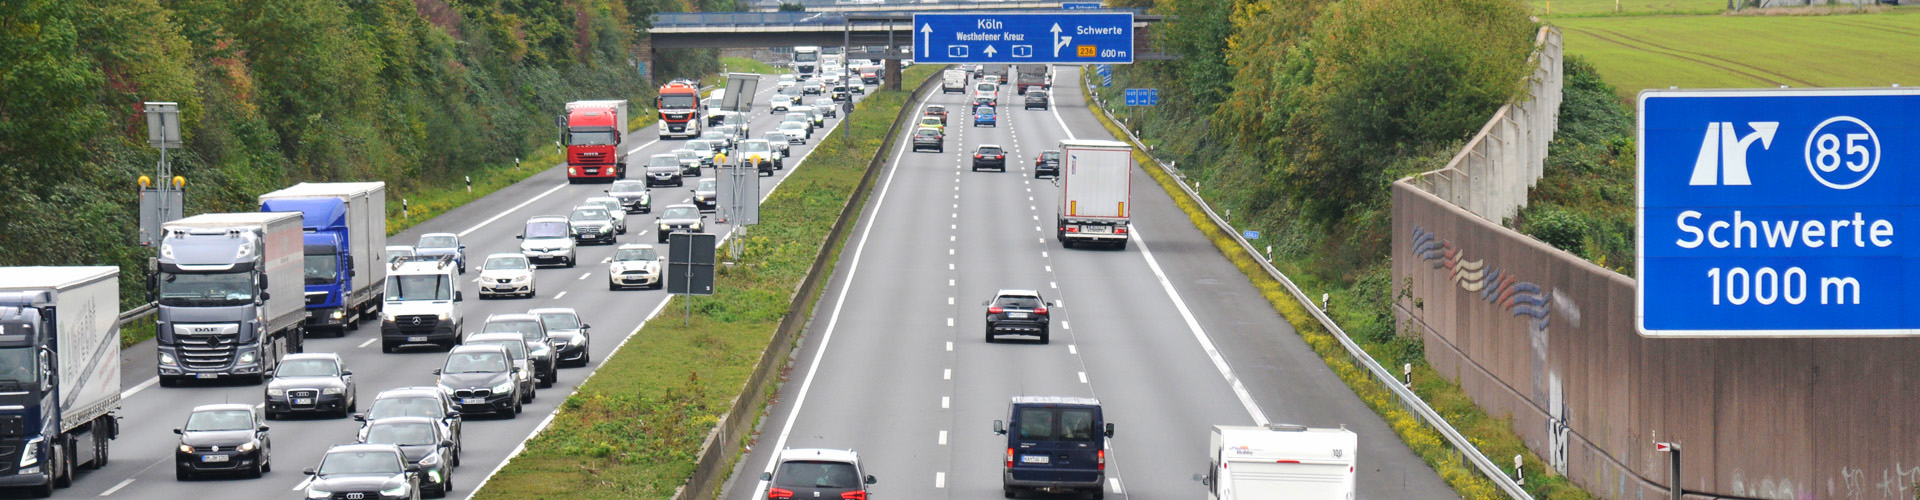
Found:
<box><xmin>267</xmin><ymin>352</ymin><xmax>359</xmax><ymax>419</ymax></box>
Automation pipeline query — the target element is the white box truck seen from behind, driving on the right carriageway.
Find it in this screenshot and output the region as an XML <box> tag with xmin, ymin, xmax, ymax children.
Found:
<box><xmin>1054</xmin><ymin>138</ymin><xmax>1133</xmax><ymax>248</ymax></box>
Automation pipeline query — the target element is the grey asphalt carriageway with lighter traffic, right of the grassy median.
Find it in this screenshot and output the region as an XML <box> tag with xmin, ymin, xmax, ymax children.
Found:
<box><xmin>726</xmin><ymin>67</ymin><xmax>1455</xmax><ymax>500</ymax></box>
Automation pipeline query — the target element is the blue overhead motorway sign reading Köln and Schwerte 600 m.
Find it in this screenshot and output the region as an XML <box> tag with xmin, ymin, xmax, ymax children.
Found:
<box><xmin>914</xmin><ymin>12</ymin><xmax>1133</xmax><ymax>63</ymax></box>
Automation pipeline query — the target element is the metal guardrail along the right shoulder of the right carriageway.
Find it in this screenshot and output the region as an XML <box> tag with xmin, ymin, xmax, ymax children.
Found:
<box><xmin>1081</xmin><ymin>71</ymin><xmax>1534</xmax><ymax>500</ymax></box>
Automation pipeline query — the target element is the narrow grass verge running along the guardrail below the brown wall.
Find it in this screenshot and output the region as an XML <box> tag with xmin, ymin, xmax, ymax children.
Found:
<box><xmin>1087</xmin><ymin>76</ymin><xmax>1594</xmax><ymax>500</ymax></box>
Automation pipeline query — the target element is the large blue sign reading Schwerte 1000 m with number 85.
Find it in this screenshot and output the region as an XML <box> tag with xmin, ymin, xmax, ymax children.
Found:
<box><xmin>1634</xmin><ymin>88</ymin><xmax>1920</xmax><ymax>337</ymax></box>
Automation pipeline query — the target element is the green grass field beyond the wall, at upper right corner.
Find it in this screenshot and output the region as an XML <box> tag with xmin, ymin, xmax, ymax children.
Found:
<box><xmin>1549</xmin><ymin>9</ymin><xmax>1920</xmax><ymax>98</ymax></box>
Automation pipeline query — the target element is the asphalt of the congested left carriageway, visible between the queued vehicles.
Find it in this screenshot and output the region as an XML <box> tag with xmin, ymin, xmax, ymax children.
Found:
<box><xmin>39</xmin><ymin>77</ymin><xmax>860</xmax><ymax>500</ymax></box>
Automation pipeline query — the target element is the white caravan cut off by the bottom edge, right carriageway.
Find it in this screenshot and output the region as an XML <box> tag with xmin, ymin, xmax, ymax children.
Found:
<box><xmin>1196</xmin><ymin>423</ymin><xmax>1359</xmax><ymax>500</ymax></box>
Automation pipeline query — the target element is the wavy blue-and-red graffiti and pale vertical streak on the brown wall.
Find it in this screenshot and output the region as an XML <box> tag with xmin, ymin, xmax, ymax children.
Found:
<box><xmin>1411</xmin><ymin>225</ymin><xmax>1580</xmax><ymax>475</ymax></box>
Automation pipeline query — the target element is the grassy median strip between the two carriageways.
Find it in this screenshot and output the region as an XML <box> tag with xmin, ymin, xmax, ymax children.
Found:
<box><xmin>474</xmin><ymin>63</ymin><xmax>931</xmax><ymax>500</ymax></box>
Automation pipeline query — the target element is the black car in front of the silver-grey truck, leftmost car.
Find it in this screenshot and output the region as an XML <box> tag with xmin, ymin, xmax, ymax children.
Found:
<box><xmin>173</xmin><ymin>404</ymin><xmax>273</xmax><ymax>481</ymax></box>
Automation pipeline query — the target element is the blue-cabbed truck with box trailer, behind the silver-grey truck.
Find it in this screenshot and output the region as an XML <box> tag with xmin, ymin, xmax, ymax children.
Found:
<box><xmin>259</xmin><ymin>183</ymin><xmax>386</xmax><ymax>335</ymax></box>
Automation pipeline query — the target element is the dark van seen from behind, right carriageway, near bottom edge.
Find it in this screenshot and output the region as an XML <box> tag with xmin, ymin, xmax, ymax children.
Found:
<box><xmin>993</xmin><ymin>396</ymin><xmax>1114</xmax><ymax>498</ymax></box>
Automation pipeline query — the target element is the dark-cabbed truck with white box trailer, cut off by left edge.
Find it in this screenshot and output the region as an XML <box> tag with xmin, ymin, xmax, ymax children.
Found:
<box><xmin>0</xmin><ymin>265</ymin><xmax>121</xmax><ymax>496</ymax></box>
